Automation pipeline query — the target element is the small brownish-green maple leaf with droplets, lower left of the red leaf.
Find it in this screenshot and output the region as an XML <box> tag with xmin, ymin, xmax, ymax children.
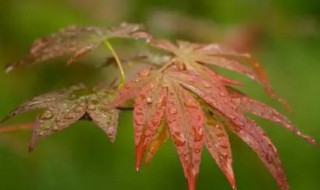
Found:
<box><xmin>3</xmin><ymin>84</ymin><xmax>119</xmax><ymax>151</ymax></box>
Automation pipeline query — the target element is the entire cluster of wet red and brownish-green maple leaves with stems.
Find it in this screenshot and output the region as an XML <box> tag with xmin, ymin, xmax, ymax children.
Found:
<box><xmin>0</xmin><ymin>23</ymin><xmax>316</xmax><ymax>190</ymax></box>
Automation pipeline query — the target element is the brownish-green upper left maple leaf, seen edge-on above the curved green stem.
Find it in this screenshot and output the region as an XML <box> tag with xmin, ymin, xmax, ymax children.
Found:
<box><xmin>6</xmin><ymin>23</ymin><xmax>150</xmax><ymax>72</ymax></box>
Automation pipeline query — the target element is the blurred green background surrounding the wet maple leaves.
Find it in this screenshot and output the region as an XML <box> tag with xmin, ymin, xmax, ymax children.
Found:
<box><xmin>0</xmin><ymin>0</ymin><xmax>320</xmax><ymax>190</ymax></box>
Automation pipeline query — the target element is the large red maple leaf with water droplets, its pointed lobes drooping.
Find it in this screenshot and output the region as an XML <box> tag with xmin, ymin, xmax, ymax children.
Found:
<box><xmin>108</xmin><ymin>39</ymin><xmax>316</xmax><ymax>190</ymax></box>
